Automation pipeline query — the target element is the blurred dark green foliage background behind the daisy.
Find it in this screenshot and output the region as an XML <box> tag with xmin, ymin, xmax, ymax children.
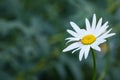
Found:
<box><xmin>0</xmin><ymin>0</ymin><xmax>120</xmax><ymax>80</ymax></box>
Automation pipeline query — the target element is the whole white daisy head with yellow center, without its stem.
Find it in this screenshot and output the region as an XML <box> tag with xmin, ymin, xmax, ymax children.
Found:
<box><xmin>63</xmin><ymin>14</ymin><xmax>115</xmax><ymax>61</ymax></box>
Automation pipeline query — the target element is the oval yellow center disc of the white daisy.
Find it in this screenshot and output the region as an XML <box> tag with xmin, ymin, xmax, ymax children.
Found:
<box><xmin>81</xmin><ymin>34</ymin><xmax>96</xmax><ymax>45</ymax></box>
